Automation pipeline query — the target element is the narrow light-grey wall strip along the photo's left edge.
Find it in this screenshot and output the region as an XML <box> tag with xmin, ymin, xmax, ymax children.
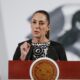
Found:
<box><xmin>0</xmin><ymin>0</ymin><xmax>8</xmax><ymax>80</ymax></box>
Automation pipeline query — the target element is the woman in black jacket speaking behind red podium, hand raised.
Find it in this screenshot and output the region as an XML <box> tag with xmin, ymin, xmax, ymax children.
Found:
<box><xmin>13</xmin><ymin>10</ymin><xmax>67</xmax><ymax>60</ymax></box>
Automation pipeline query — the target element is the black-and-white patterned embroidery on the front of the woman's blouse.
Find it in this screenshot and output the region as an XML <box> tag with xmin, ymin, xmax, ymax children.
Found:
<box><xmin>32</xmin><ymin>42</ymin><xmax>50</xmax><ymax>59</ymax></box>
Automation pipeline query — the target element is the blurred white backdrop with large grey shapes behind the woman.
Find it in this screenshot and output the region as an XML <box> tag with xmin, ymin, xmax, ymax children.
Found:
<box><xmin>0</xmin><ymin>0</ymin><xmax>80</xmax><ymax>80</ymax></box>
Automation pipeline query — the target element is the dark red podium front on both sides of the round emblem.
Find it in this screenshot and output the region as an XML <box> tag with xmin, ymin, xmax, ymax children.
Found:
<box><xmin>8</xmin><ymin>60</ymin><xmax>80</xmax><ymax>80</ymax></box>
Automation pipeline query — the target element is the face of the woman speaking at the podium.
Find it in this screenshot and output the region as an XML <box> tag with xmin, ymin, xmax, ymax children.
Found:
<box><xmin>31</xmin><ymin>13</ymin><xmax>49</xmax><ymax>38</ymax></box>
